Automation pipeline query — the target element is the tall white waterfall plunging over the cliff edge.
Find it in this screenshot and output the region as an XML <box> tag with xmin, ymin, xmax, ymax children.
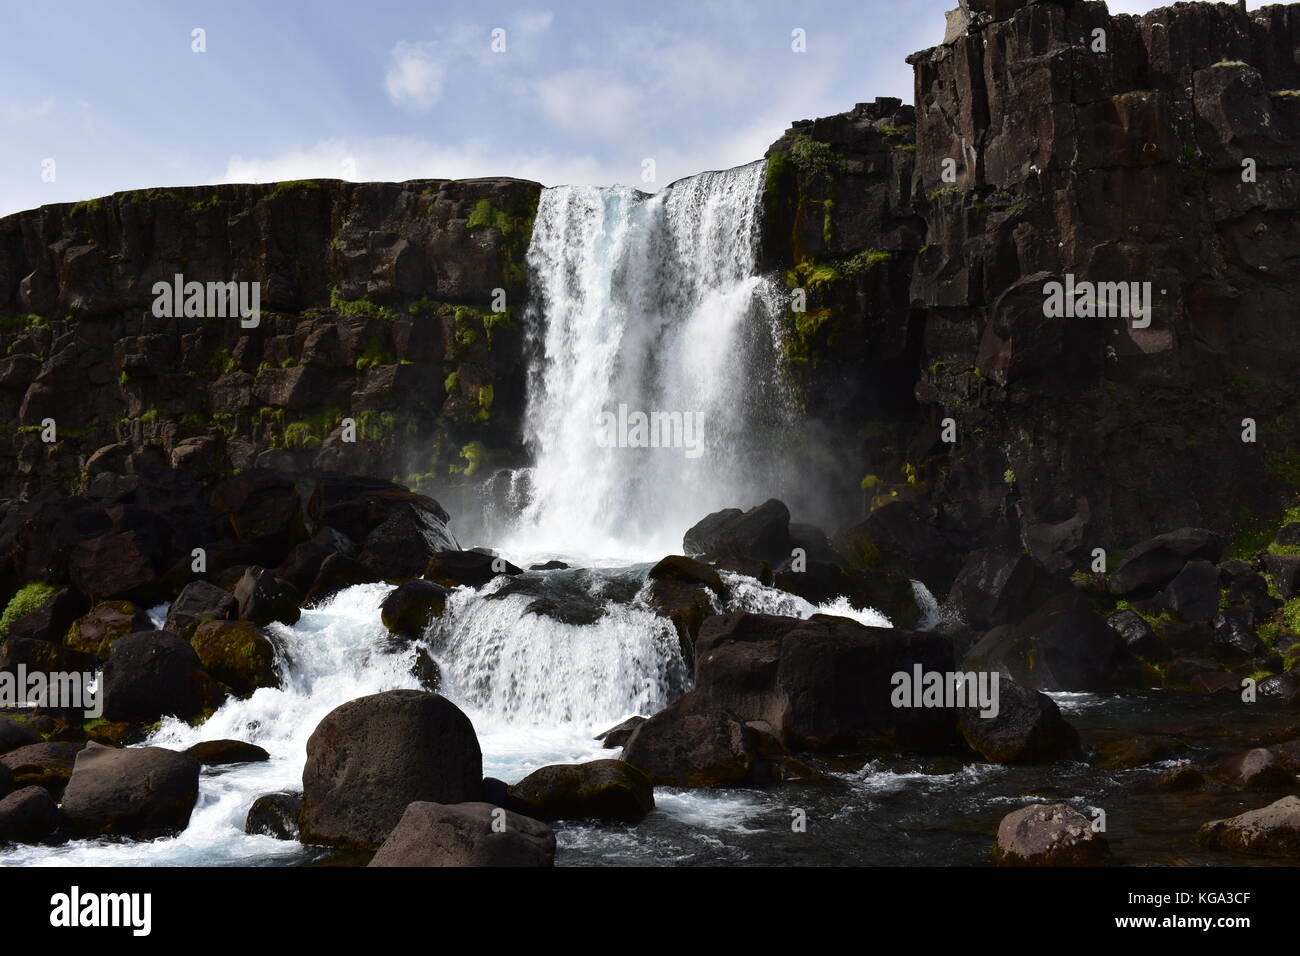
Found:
<box><xmin>503</xmin><ymin>161</ymin><xmax>793</xmax><ymax>558</ymax></box>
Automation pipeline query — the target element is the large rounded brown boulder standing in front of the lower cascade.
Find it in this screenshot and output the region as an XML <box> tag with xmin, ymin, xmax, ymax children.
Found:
<box><xmin>302</xmin><ymin>691</ymin><xmax>482</xmax><ymax>849</ymax></box>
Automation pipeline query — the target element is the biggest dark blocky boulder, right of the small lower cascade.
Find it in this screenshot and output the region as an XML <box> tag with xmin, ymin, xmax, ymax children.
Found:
<box><xmin>696</xmin><ymin>613</ymin><xmax>961</xmax><ymax>752</ymax></box>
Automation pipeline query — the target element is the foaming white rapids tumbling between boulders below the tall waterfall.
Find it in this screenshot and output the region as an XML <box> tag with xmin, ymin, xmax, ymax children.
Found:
<box><xmin>0</xmin><ymin>567</ymin><xmax>889</xmax><ymax>866</ymax></box>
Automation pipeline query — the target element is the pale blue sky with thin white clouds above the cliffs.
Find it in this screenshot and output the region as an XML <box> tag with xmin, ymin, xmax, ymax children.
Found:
<box><xmin>0</xmin><ymin>0</ymin><xmax>1222</xmax><ymax>215</ymax></box>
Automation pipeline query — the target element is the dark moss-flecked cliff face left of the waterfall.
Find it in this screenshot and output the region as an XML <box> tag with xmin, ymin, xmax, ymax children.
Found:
<box><xmin>0</xmin><ymin>178</ymin><xmax>541</xmax><ymax>528</ymax></box>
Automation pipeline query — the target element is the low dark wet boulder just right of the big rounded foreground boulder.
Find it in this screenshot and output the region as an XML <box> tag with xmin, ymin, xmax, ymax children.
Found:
<box><xmin>510</xmin><ymin>760</ymin><xmax>654</xmax><ymax>823</ymax></box>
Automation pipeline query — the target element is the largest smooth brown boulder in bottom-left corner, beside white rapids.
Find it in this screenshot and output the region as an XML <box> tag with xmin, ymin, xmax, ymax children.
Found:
<box><xmin>62</xmin><ymin>744</ymin><xmax>199</xmax><ymax>839</ymax></box>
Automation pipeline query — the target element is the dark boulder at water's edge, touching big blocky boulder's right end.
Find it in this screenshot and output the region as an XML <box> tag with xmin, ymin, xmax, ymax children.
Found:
<box><xmin>958</xmin><ymin>680</ymin><xmax>1080</xmax><ymax>763</ymax></box>
